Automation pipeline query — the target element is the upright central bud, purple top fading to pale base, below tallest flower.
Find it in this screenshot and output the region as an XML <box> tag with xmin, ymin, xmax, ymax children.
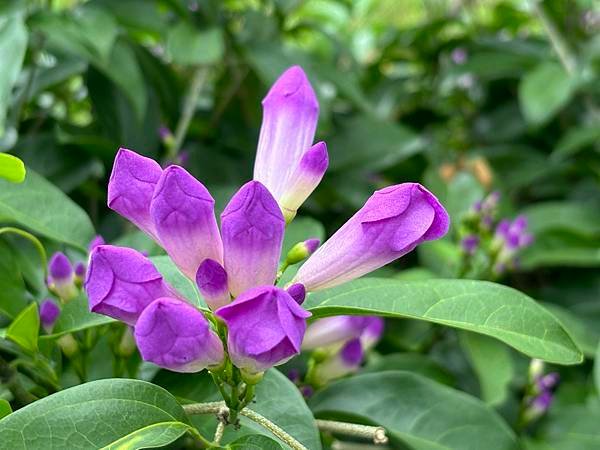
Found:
<box><xmin>221</xmin><ymin>181</ymin><xmax>285</xmax><ymax>297</ymax></box>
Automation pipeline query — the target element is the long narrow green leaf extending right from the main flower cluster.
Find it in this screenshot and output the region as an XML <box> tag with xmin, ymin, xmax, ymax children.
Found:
<box><xmin>304</xmin><ymin>278</ymin><xmax>583</xmax><ymax>364</ymax></box>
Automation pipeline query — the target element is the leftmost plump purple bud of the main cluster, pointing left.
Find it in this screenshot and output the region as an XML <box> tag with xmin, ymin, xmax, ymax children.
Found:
<box><xmin>85</xmin><ymin>245</ymin><xmax>177</xmax><ymax>325</ymax></box>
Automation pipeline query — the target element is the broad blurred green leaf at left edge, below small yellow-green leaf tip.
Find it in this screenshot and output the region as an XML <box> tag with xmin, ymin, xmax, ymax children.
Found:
<box><xmin>0</xmin><ymin>169</ymin><xmax>94</xmax><ymax>250</ymax></box>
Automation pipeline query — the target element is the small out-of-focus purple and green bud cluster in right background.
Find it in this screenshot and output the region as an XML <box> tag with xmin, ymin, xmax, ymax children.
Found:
<box><xmin>459</xmin><ymin>191</ymin><xmax>533</xmax><ymax>279</ymax></box>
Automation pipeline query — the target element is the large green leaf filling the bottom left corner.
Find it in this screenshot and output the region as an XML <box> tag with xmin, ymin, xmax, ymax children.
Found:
<box><xmin>0</xmin><ymin>379</ymin><xmax>187</xmax><ymax>450</ymax></box>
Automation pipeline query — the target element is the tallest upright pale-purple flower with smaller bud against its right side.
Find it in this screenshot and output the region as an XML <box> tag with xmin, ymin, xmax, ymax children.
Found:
<box><xmin>254</xmin><ymin>66</ymin><xmax>327</xmax><ymax>212</ymax></box>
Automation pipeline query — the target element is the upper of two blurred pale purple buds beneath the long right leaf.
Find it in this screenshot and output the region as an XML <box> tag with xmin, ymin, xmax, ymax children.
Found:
<box><xmin>302</xmin><ymin>316</ymin><xmax>372</xmax><ymax>350</ymax></box>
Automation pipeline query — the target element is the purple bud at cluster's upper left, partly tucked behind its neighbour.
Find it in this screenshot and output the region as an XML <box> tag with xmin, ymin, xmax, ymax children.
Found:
<box><xmin>108</xmin><ymin>148</ymin><xmax>162</xmax><ymax>242</ymax></box>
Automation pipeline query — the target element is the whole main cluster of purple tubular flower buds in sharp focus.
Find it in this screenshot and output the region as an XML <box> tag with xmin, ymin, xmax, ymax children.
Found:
<box><xmin>85</xmin><ymin>67</ymin><xmax>449</xmax><ymax>400</ymax></box>
